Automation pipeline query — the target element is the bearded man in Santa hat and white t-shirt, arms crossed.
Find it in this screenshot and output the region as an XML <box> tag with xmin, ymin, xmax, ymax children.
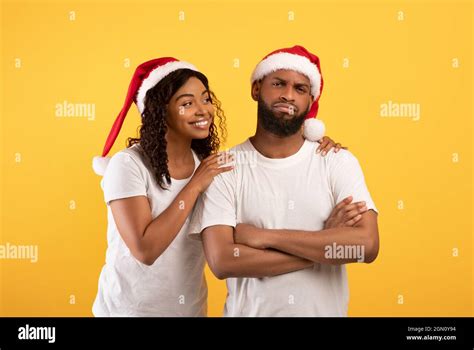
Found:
<box><xmin>190</xmin><ymin>46</ymin><xmax>378</xmax><ymax>316</ymax></box>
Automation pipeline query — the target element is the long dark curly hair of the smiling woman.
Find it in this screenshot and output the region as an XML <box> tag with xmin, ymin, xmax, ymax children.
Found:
<box><xmin>127</xmin><ymin>69</ymin><xmax>227</xmax><ymax>189</ymax></box>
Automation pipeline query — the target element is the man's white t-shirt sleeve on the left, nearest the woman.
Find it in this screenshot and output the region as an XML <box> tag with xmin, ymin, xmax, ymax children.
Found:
<box><xmin>188</xmin><ymin>171</ymin><xmax>237</xmax><ymax>239</ymax></box>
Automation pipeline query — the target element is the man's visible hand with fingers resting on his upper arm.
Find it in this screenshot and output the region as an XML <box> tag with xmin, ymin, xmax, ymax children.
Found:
<box><xmin>324</xmin><ymin>196</ymin><xmax>367</xmax><ymax>229</ymax></box>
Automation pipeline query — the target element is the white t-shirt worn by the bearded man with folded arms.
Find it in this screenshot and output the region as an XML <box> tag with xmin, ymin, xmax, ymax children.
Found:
<box><xmin>190</xmin><ymin>140</ymin><xmax>376</xmax><ymax>316</ymax></box>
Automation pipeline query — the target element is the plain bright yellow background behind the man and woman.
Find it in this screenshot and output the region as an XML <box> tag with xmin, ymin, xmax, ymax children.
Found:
<box><xmin>0</xmin><ymin>1</ymin><xmax>474</xmax><ymax>316</ymax></box>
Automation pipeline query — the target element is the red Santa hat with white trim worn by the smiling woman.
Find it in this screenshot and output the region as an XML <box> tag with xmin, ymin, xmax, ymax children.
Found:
<box><xmin>92</xmin><ymin>57</ymin><xmax>197</xmax><ymax>175</ymax></box>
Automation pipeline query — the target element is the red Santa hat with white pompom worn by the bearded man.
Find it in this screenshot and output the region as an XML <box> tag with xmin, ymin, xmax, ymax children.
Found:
<box><xmin>251</xmin><ymin>45</ymin><xmax>325</xmax><ymax>141</ymax></box>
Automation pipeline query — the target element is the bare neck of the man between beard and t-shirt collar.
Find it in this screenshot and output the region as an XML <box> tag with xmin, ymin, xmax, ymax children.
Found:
<box><xmin>249</xmin><ymin>124</ymin><xmax>304</xmax><ymax>158</ymax></box>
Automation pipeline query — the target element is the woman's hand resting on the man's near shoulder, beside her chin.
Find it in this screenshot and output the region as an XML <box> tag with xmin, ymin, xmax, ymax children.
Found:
<box><xmin>189</xmin><ymin>152</ymin><xmax>234</xmax><ymax>193</ymax></box>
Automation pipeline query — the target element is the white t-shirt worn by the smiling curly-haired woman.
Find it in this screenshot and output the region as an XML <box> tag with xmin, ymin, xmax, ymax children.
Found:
<box><xmin>92</xmin><ymin>145</ymin><xmax>207</xmax><ymax>316</ymax></box>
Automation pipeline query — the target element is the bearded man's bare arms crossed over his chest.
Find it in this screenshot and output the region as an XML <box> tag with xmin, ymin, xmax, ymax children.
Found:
<box><xmin>202</xmin><ymin>197</ymin><xmax>378</xmax><ymax>279</ymax></box>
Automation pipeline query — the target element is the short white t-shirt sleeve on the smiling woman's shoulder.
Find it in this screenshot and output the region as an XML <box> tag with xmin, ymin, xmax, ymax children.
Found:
<box><xmin>102</xmin><ymin>153</ymin><xmax>147</xmax><ymax>205</ymax></box>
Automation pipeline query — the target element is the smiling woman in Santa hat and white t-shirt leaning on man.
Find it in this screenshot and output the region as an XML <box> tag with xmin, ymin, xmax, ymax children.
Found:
<box><xmin>93</xmin><ymin>57</ymin><xmax>352</xmax><ymax>316</ymax></box>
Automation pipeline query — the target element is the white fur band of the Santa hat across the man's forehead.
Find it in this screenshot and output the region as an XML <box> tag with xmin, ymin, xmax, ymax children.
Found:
<box><xmin>251</xmin><ymin>52</ymin><xmax>321</xmax><ymax>99</ymax></box>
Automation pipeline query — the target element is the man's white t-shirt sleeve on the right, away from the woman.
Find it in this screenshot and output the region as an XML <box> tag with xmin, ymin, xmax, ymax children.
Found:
<box><xmin>329</xmin><ymin>150</ymin><xmax>378</xmax><ymax>212</ymax></box>
